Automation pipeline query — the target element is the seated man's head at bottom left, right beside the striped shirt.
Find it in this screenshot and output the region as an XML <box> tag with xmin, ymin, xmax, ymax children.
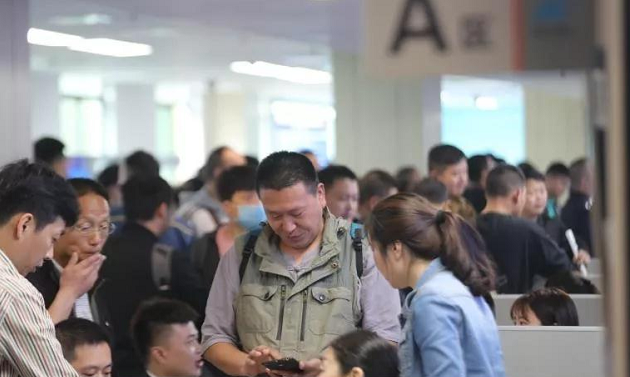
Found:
<box><xmin>55</xmin><ymin>318</ymin><xmax>112</xmax><ymax>377</ymax></box>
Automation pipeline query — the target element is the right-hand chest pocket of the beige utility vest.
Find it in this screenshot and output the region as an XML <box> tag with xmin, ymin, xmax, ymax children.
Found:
<box><xmin>308</xmin><ymin>287</ymin><xmax>356</xmax><ymax>335</ymax></box>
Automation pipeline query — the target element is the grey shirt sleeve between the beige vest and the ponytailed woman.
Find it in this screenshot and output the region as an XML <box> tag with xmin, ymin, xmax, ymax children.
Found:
<box><xmin>361</xmin><ymin>242</ymin><xmax>402</xmax><ymax>343</ymax></box>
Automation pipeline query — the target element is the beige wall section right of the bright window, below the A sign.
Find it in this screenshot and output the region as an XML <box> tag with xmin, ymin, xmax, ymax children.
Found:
<box><xmin>524</xmin><ymin>86</ymin><xmax>588</xmax><ymax>171</ymax></box>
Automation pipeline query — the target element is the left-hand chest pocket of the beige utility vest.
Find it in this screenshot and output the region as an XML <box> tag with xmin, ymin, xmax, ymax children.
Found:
<box><xmin>236</xmin><ymin>284</ymin><xmax>278</xmax><ymax>333</ymax></box>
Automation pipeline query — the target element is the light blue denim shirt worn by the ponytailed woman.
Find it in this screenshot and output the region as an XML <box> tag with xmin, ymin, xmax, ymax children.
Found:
<box><xmin>399</xmin><ymin>259</ymin><xmax>505</xmax><ymax>377</ymax></box>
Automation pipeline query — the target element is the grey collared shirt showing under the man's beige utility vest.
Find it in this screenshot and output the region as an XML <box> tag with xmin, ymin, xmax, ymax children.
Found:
<box><xmin>201</xmin><ymin>242</ymin><xmax>402</xmax><ymax>352</ymax></box>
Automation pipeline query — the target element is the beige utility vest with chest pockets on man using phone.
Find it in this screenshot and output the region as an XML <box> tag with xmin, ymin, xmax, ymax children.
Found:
<box><xmin>235</xmin><ymin>215</ymin><xmax>366</xmax><ymax>360</ymax></box>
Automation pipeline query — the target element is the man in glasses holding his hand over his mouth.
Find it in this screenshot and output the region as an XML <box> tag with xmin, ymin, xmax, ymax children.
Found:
<box><xmin>27</xmin><ymin>179</ymin><xmax>114</xmax><ymax>324</ymax></box>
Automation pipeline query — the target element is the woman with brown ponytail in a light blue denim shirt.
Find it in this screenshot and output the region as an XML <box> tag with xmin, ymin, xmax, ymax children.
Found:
<box><xmin>366</xmin><ymin>194</ymin><xmax>505</xmax><ymax>377</ymax></box>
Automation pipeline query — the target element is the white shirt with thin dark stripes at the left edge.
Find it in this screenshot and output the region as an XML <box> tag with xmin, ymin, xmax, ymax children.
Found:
<box><xmin>0</xmin><ymin>250</ymin><xmax>78</xmax><ymax>377</ymax></box>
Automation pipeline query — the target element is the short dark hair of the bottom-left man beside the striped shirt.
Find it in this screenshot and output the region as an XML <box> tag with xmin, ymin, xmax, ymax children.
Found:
<box><xmin>55</xmin><ymin>318</ymin><xmax>110</xmax><ymax>362</ymax></box>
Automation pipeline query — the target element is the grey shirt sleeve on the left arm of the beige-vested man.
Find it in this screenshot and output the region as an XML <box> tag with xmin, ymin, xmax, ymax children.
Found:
<box><xmin>201</xmin><ymin>247</ymin><xmax>240</xmax><ymax>352</ymax></box>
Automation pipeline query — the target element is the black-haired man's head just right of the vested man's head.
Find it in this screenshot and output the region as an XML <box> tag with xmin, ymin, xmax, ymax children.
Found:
<box><xmin>318</xmin><ymin>165</ymin><xmax>359</xmax><ymax>221</ymax></box>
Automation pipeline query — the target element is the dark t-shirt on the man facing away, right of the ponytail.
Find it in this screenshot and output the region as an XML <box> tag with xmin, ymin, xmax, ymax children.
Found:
<box><xmin>477</xmin><ymin>213</ymin><xmax>571</xmax><ymax>293</ymax></box>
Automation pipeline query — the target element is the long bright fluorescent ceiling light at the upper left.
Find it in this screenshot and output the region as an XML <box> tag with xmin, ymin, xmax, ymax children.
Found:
<box><xmin>27</xmin><ymin>28</ymin><xmax>153</xmax><ymax>58</ymax></box>
